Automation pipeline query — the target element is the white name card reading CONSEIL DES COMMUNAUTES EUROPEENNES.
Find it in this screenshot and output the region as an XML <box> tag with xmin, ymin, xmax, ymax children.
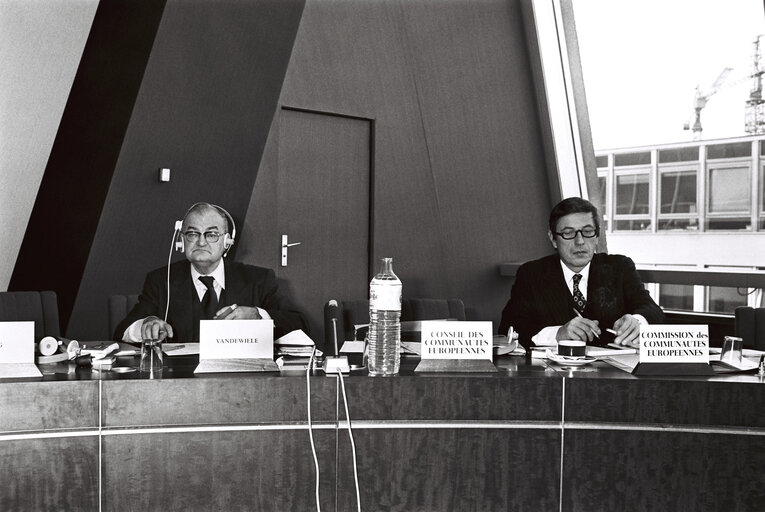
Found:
<box><xmin>420</xmin><ymin>320</ymin><xmax>493</xmax><ymax>361</ymax></box>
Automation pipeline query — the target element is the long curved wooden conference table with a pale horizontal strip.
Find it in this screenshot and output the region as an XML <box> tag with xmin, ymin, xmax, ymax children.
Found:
<box><xmin>0</xmin><ymin>346</ymin><xmax>765</xmax><ymax>511</ymax></box>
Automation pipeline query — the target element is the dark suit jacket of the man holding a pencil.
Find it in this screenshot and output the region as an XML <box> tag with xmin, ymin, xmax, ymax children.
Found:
<box><xmin>499</xmin><ymin>253</ymin><xmax>664</xmax><ymax>347</ymax></box>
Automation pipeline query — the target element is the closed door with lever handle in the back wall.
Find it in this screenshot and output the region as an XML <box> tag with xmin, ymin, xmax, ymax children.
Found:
<box><xmin>277</xmin><ymin>108</ymin><xmax>373</xmax><ymax>344</ymax></box>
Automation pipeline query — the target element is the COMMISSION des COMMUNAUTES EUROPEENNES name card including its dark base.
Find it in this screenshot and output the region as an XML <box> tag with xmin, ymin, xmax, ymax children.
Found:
<box><xmin>632</xmin><ymin>325</ymin><xmax>715</xmax><ymax>376</ymax></box>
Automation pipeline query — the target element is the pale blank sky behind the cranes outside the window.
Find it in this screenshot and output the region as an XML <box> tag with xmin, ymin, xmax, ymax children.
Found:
<box><xmin>573</xmin><ymin>0</ymin><xmax>765</xmax><ymax>150</ymax></box>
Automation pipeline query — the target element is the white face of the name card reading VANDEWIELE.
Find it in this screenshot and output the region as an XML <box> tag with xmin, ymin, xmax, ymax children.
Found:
<box><xmin>199</xmin><ymin>320</ymin><xmax>274</xmax><ymax>359</ymax></box>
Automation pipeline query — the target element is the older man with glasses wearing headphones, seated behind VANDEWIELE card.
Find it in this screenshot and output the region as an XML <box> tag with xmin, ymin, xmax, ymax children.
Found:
<box><xmin>114</xmin><ymin>203</ymin><xmax>306</xmax><ymax>342</ymax></box>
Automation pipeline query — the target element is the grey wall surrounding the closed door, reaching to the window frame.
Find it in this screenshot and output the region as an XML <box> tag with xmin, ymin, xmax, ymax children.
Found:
<box><xmin>246</xmin><ymin>0</ymin><xmax>551</xmax><ymax>328</ymax></box>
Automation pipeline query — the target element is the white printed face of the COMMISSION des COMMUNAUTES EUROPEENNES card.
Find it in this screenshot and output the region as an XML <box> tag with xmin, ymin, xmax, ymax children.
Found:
<box><xmin>640</xmin><ymin>325</ymin><xmax>709</xmax><ymax>363</ymax></box>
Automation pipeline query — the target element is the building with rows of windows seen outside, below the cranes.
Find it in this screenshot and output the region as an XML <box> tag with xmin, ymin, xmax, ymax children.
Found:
<box><xmin>595</xmin><ymin>135</ymin><xmax>765</xmax><ymax>314</ymax></box>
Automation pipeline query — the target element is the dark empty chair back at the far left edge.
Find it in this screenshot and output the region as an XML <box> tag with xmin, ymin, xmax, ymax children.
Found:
<box><xmin>0</xmin><ymin>291</ymin><xmax>61</xmax><ymax>341</ymax></box>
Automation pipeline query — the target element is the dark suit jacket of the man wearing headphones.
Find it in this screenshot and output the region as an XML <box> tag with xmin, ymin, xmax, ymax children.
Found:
<box><xmin>114</xmin><ymin>259</ymin><xmax>308</xmax><ymax>341</ymax></box>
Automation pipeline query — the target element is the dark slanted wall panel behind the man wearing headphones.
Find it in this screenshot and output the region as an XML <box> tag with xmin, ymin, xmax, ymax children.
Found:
<box><xmin>66</xmin><ymin>0</ymin><xmax>303</xmax><ymax>339</ymax></box>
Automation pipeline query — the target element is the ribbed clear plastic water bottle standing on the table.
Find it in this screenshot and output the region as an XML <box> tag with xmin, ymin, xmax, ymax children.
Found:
<box><xmin>367</xmin><ymin>258</ymin><xmax>401</xmax><ymax>377</ymax></box>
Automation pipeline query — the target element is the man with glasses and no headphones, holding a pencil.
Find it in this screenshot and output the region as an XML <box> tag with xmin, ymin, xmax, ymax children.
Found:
<box><xmin>499</xmin><ymin>197</ymin><xmax>664</xmax><ymax>347</ymax></box>
